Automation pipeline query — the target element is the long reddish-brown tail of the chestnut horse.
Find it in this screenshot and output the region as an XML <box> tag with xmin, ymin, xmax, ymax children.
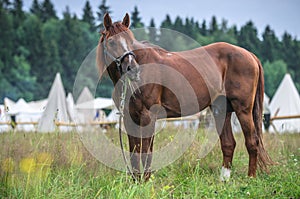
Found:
<box><xmin>252</xmin><ymin>54</ymin><xmax>275</xmax><ymax>172</ymax></box>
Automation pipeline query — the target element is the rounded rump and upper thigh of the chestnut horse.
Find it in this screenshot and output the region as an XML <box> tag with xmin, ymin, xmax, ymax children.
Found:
<box><xmin>204</xmin><ymin>42</ymin><xmax>261</xmax><ymax>105</ymax></box>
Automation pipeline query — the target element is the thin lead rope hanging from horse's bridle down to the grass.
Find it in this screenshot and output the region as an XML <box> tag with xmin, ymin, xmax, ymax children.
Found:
<box><xmin>119</xmin><ymin>77</ymin><xmax>137</xmax><ymax>181</ymax></box>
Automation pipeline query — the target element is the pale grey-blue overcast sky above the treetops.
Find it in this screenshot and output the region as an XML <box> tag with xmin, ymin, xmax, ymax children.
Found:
<box><xmin>24</xmin><ymin>0</ymin><xmax>300</xmax><ymax>39</ymax></box>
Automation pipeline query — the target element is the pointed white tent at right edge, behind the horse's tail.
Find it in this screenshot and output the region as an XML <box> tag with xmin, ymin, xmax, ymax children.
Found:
<box><xmin>270</xmin><ymin>74</ymin><xmax>300</xmax><ymax>133</ymax></box>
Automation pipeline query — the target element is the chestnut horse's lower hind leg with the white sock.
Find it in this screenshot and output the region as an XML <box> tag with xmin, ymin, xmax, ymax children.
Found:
<box><xmin>215</xmin><ymin>109</ymin><xmax>236</xmax><ymax>181</ymax></box>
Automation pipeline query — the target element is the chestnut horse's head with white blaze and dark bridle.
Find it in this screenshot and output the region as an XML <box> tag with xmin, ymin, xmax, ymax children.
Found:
<box><xmin>98</xmin><ymin>13</ymin><xmax>139</xmax><ymax>80</ymax></box>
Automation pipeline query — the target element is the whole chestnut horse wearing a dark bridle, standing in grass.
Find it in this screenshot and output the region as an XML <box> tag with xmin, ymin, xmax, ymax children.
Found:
<box><xmin>97</xmin><ymin>14</ymin><xmax>273</xmax><ymax>180</ymax></box>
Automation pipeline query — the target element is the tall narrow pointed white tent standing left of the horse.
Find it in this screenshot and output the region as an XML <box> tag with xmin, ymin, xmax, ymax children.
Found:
<box><xmin>38</xmin><ymin>73</ymin><xmax>69</xmax><ymax>132</ymax></box>
